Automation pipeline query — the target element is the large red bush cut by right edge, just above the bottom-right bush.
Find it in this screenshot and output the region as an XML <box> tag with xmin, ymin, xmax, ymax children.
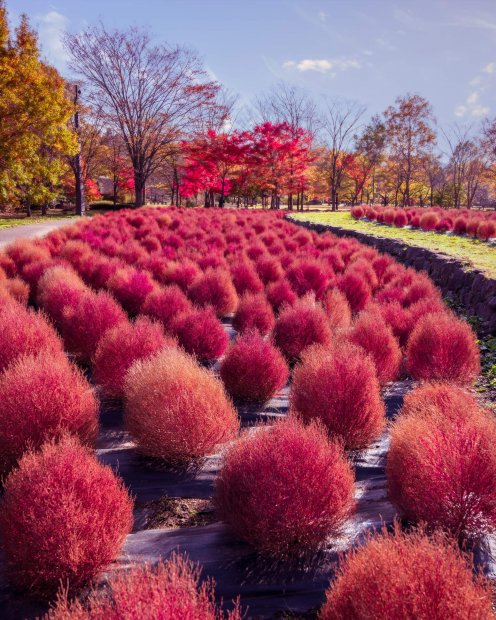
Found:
<box><xmin>387</xmin><ymin>402</ymin><xmax>496</xmax><ymax>538</ymax></box>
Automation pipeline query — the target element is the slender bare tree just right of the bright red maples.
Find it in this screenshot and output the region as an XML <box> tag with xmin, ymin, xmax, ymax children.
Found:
<box><xmin>323</xmin><ymin>101</ymin><xmax>365</xmax><ymax>211</ymax></box>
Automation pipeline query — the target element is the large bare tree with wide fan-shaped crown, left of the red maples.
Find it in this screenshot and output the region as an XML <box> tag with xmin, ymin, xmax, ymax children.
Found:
<box><xmin>65</xmin><ymin>24</ymin><xmax>219</xmax><ymax>206</ymax></box>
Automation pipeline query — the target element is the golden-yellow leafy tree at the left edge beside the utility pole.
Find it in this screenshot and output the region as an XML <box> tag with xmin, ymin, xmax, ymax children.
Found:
<box><xmin>0</xmin><ymin>0</ymin><xmax>77</xmax><ymax>215</ymax></box>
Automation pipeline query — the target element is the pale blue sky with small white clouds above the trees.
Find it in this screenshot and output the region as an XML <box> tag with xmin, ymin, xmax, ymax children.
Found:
<box><xmin>6</xmin><ymin>0</ymin><xmax>496</xmax><ymax>128</ymax></box>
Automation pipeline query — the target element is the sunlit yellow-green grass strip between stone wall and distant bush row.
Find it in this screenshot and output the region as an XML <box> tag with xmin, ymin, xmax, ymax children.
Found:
<box><xmin>291</xmin><ymin>211</ymin><xmax>496</xmax><ymax>278</ymax></box>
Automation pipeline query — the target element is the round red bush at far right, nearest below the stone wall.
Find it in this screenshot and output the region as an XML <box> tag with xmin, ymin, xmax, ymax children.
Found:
<box><xmin>406</xmin><ymin>312</ymin><xmax>480</xmax><ymax>385</ymax></box>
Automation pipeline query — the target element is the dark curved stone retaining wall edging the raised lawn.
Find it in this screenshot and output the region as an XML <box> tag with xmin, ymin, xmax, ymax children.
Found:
<box><xmin>289</xmin><ymin>217</ymin><xmax>496</xmax><ymax>335</ymax></box>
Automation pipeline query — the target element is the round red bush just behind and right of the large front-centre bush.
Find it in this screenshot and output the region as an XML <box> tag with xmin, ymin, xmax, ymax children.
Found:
<box><xmin>290</xmin><ymin>342</ymin><xmax>385</xmax><ymax>449</ymax></box>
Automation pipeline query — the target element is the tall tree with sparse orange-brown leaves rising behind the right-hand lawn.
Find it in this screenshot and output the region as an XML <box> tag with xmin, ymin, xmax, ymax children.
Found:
<box><xmin>384</xmin><ymin>94</ymin><xmax>436</xmax><ymax>205</ymax></box>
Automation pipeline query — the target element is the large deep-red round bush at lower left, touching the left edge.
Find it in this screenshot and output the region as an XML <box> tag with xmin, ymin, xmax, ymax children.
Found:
<box><xmin>0</xmin><ymin>438</ymin><xmax>133</xmax><ymax>596</ymax></box>
